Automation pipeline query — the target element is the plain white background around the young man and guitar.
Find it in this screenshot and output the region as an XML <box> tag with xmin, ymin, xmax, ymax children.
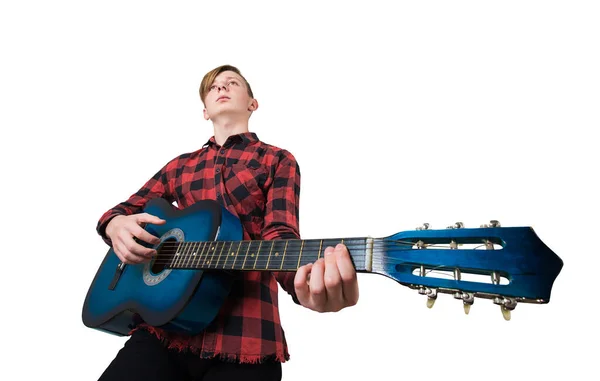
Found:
<box><xmin>0</xmin><ymin>0</ymin><xmax>600</xmax><ymax>381</ymax></box>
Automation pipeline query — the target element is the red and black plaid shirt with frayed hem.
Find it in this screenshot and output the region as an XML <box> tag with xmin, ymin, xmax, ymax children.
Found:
<box><xmin>97</xmin><ymin>132</ymin><xmax>300</xmax><ymax>362</ymax></box>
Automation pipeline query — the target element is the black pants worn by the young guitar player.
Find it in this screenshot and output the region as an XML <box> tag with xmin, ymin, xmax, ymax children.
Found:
<box><xmin>99</xmin><ymin>330</ymin><xmax>281</xmax><ymax>381</ymax></box>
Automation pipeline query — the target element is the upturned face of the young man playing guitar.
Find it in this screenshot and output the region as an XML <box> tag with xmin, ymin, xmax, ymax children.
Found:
<box><xmin>204</xmin><ymin>71</ymin><xmax>258</xmax><ymax>121</ymax></box>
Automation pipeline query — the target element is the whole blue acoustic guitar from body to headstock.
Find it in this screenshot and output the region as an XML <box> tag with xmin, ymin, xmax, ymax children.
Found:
<box><xmin>82</xmin><ymin>198</ymin><xmax>563</xmax><ymax>336</ymax></box>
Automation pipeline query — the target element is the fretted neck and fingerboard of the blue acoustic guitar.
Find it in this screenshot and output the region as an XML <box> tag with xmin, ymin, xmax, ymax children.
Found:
<box><xmin>158</xmin><ymin>237</ymin><xmax>374</xmax><ymax>272</ymax></box>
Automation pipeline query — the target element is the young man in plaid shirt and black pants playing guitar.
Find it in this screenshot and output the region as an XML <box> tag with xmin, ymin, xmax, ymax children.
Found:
<box><xmin>97</xmin><ymin>65</ymin><xmax>358</xmax><ymax>381</ymax></box>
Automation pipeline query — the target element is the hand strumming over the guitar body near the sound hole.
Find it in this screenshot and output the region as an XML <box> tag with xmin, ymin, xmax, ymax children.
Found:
<box><xmin>106</xmin><ymin>213</ymin><xmax>165</xmax><ymax>264</ymax></box>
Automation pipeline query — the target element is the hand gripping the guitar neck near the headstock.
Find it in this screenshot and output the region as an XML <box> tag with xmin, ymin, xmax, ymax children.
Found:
<box><xmin>294</xmin><ymin>244</ymin><xmax>358</xmax><ymax>312</ymax></box>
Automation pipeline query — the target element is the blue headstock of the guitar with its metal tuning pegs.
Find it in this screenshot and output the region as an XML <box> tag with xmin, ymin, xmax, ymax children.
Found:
<box><xmin>372</xmin><ymin>220</ymin><xmax>563</xmax><ymax>320</ymax></box>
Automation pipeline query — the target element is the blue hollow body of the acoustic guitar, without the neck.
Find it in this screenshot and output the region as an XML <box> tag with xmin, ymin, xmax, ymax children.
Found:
<box><xmin>82</xmin><ymin>198</ymin><xmax>243</xmax><ymax>336</ymax></box>
